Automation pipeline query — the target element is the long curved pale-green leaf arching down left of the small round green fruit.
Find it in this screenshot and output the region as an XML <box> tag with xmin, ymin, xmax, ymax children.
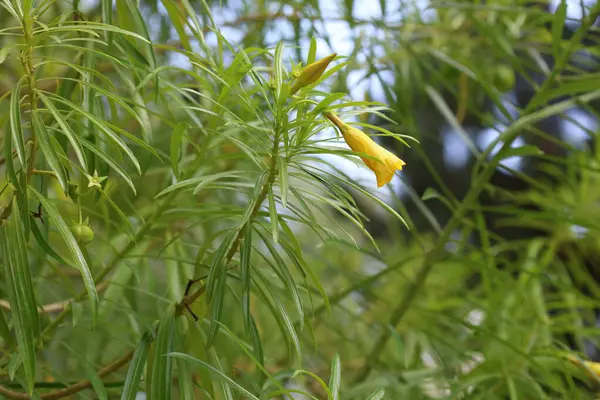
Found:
<box><xmin>29</xmin><ymin>187</ymin><xmax>98</xmax><ymax>325</ymax></box>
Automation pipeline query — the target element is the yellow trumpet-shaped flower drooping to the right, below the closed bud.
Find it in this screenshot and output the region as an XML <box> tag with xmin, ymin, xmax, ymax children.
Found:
<box><xmin>324</xmin><ymin>112</ymin><xmax>406</xmax><ymax>187</ymax></box>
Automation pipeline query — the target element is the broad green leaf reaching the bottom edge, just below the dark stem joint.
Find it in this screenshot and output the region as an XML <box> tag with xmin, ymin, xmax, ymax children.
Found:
<box><xmin>150</xmin><ymin>306</ymin><xmax>175</xmax><ymax>400</ymax></box>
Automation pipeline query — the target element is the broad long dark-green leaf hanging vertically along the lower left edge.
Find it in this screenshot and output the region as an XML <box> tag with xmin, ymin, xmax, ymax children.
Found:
<box><xmin>0</xmin><ymin>203</ymin><xmax>40</xmax><ymax>395</ymax></box>
